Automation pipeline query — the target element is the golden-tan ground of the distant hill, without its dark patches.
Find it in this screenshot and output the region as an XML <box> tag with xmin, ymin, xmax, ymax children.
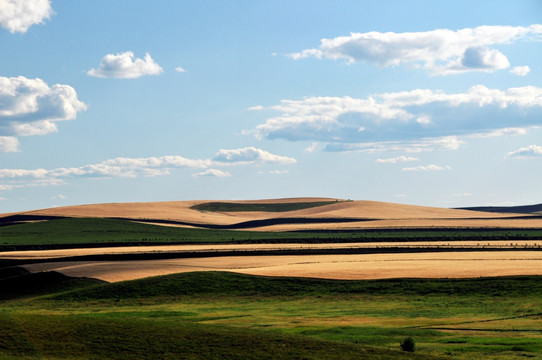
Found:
<box><xmin>5</xmin><ymin>198</ymin><xmax>542</xmax><ymax>231</ymax></box>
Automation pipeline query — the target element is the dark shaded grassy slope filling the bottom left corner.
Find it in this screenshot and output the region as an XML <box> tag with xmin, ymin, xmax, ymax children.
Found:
<box><xmin>0</xmin><ymin>315</ymin><xmax>436</xmax><ymax>359</ymax></box>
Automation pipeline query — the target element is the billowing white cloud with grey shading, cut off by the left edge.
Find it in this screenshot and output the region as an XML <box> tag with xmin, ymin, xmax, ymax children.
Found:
<box><xmin>0</xmin><ymin>76</ymin><xmax>87</xmax><ymax>151</ymax></box>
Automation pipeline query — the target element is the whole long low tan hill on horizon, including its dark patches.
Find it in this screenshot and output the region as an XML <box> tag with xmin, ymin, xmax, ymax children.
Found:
<box><xmin>0</xmin><ymin>197</ymin><xmax>542</xmax><ymax>231</ymax></box>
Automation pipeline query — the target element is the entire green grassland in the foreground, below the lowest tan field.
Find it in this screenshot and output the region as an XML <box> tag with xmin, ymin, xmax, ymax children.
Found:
<box><xmin>0</xmin><ymin>269</ymin><xmax>542</xmax><ymax>359</ymax></box>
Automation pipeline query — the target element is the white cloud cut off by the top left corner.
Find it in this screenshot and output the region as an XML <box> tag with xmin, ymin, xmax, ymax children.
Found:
<box><xmin>0</xmin><ymin>0</ymin><xmax>53</xmax><ymax>34</ymax></box>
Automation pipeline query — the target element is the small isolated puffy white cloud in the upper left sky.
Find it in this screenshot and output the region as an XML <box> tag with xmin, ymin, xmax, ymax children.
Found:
<box><xmin>87</xmin><ymin>51</ymin><xmax>163</xmax><ymax>79</ymax></box>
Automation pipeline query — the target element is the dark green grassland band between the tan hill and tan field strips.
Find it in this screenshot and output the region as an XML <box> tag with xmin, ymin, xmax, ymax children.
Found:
<box><xmin>0</xmin><ymin>218</ymin><xmax>542</xmax><ymax>251</ymax></box>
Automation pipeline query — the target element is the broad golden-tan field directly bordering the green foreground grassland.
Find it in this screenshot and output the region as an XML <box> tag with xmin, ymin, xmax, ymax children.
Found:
<box><xmin>24</xmin><ymin>251</ymin><xmax>542</xmax><ymax>282</ymax></box>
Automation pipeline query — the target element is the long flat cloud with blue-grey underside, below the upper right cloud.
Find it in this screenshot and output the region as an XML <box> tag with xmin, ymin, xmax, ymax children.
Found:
<box><xmin>253</xmin><ymin>85</ymin><xmax>542</xmax><ymax>152</ymax></box>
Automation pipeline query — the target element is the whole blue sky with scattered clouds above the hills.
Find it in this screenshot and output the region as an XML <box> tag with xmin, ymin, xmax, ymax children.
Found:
<box><xmin>0</xmin><ymin>0</ymin><xmax>542</xmax><ymax>213</ymax></box>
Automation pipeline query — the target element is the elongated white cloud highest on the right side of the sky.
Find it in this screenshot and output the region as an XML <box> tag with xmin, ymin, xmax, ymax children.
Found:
<box><xmin>289</xmin><ymin>24</ymin><xmax>542</xmax><ymax>75</ymax></box>
